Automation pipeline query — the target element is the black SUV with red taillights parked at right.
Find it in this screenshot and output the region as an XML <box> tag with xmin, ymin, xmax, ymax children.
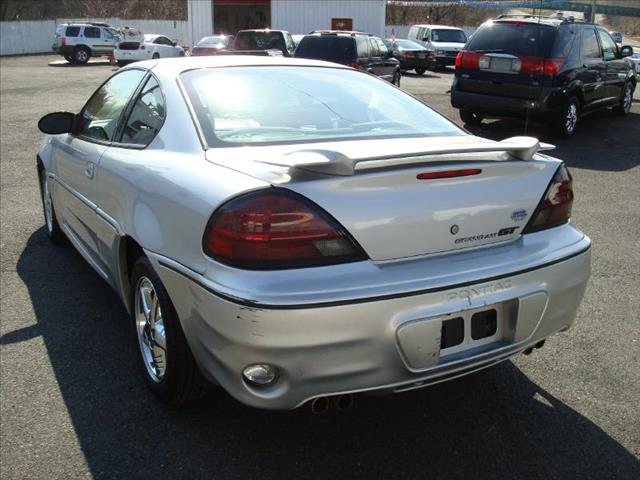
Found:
<box><xmin>451</xmin><ymin>16</ymin><xmax>636</xmax><ymax>136</ymax></box>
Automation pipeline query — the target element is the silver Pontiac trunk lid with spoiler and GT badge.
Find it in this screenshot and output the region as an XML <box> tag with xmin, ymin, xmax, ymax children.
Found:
<box><xmin>207</xmin><ymin>136</ymin><xmax>558</xmax><ymax>261</ymax></box>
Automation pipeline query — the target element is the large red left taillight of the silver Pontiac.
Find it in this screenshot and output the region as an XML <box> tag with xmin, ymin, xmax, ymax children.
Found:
<box><xmin>202</xmin><ymin>189</ymin><xmax>367</xmax><ymax>269</ymax></box>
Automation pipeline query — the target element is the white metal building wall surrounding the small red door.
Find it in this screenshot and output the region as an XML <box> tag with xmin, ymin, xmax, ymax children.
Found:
<box><xmin>271</xmin><ymin>0</ymin><xmax>386</xmax><ymax>35</ymax></box>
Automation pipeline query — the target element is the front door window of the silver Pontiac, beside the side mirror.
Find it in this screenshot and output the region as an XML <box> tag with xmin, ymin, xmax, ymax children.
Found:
<box><xmin>79</xmin><ymin>70</ymin><xmax>145</xmax><ymax>142</ymax></box>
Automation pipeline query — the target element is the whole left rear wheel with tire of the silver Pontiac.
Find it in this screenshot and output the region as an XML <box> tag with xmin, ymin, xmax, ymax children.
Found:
<box><xmin>129</xmin><ymin>256</ymin><xmax>209</xmax><ymax>405</ymax></box>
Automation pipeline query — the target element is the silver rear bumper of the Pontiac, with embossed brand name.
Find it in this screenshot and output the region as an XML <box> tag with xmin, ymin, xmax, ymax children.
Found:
<box><xmin>149</xmin><ymin>228</ymin><xmax>590</xmax><ymax>409</ymax></box>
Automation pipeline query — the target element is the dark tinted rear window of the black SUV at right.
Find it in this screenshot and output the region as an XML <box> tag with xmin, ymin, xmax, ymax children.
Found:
<box><xmin>466</xmin><ymin>22</ymin><xmax>556</xmax><ymax>57</ymax></box>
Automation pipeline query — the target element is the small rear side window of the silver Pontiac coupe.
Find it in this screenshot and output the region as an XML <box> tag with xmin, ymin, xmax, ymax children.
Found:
<box><xmin>121</xmin><ymin>77</ymin><xmax>165</xmax><ymax>146</ymax></box>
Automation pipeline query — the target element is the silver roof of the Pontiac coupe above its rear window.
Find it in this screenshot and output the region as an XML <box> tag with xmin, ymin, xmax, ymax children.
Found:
<box><xmin>121</xmin><ymin>55</ymin><xmax>349</xmax><ymax>78</ymax></box>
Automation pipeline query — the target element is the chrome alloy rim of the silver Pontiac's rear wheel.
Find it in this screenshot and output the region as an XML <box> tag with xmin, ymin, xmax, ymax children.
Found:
<box><xmin>135</xmin><ymin>276</ymin><xmax>167</xmax><ymax>383</ymax></box>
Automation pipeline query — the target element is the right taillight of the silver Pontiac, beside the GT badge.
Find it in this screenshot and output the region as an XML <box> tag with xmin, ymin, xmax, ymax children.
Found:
<box><xmin>522</xmin><ymin>164</ymin><xmax>573</xmax><ymax>233</ymax></box>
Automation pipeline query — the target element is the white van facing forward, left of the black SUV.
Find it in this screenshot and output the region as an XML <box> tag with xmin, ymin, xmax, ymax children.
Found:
<box><xmin>408</xmin><ymin>25</ymin><xmax>467</xmax><ymax>67</ymax></box>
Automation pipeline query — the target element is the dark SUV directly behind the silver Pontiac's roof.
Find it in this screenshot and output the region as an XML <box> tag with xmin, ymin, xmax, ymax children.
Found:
<box><xmin>293</xmin><ymin>30</ymin><xmax>400</xmax><ymax>86</ymax></box>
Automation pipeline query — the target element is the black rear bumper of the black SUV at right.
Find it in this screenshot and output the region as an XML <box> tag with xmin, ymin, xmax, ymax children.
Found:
<box><xmin>451</xmin><ymin>78</ymin><xmax>563</xmax><ymax>117</ymax></box>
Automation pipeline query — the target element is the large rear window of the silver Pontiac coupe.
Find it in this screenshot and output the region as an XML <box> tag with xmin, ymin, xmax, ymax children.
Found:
<box><xmin>181</xmin><ymin>66</ymin><xmax>465</xmax><ymax>146</ymax></box>
